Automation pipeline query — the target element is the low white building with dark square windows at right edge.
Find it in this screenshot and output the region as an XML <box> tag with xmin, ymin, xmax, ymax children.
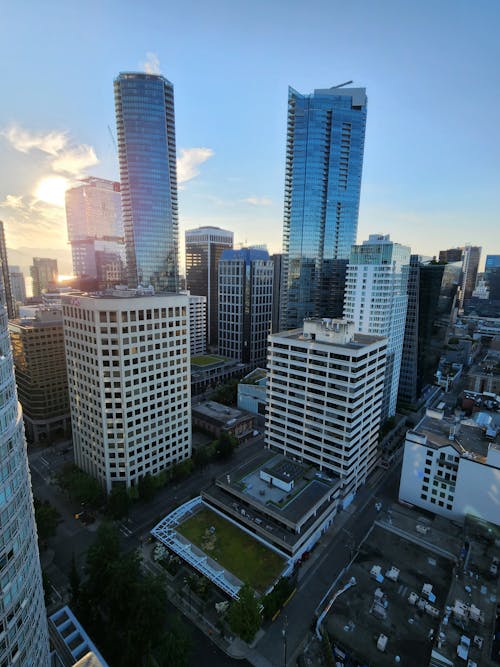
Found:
<box><xmin>399</xmin><ymin>402</ymin><xmax>500</xmax><ymax>525</ymax></box>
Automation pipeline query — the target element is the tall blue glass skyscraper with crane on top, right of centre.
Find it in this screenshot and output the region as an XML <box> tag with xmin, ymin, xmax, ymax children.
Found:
<box><xmin>281</xmin><ymin>86</ymin><xmax>367</xmax><ymax>329</ymax></box>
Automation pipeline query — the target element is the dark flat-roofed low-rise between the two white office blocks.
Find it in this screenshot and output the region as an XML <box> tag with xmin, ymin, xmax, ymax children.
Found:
<box><xmin>191</xmin><ymin>401</ymin><xmax>254</xmax><ymax>442</ymax></box>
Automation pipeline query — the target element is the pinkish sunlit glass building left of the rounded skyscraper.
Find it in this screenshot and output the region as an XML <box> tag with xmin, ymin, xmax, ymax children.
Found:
<box><xmin>66</xmin><ymin>177</ymin><xmax>125</xmax><ymax>287</ymax></box>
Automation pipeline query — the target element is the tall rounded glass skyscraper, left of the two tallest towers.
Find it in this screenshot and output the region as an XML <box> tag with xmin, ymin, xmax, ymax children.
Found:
<box><xmin>114</xmin><ymin>72</ymin><xmax>179</xmax><ymax>292</ymax></box>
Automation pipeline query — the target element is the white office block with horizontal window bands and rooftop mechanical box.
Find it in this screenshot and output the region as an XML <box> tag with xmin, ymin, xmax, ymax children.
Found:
<box><xmin>266</xmin><ymin>319</ymin><xmax>387</xmax><ymax>507</ymax></box>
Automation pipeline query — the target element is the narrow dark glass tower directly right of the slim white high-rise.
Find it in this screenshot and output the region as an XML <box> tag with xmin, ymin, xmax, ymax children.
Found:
<box><xmin>398</xmin><ymin>255</ymin><xmax>445</xmax><ymax>405</ymax></box>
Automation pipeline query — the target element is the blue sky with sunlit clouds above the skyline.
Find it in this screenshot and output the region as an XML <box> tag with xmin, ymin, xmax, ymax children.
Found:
<box><xmin>0</xmin><ymin>0</ymin><xmax>500</xmax><ymax>274</ymax></box>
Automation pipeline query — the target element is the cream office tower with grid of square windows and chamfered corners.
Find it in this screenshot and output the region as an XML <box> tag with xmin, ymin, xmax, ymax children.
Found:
<box><xmin>62</xmin><ymin>288</ymin><xmax>191</xmax><ymax>492</ymax></box>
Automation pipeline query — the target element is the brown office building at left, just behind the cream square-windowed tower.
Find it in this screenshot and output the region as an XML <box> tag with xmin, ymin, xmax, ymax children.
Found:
<box><xmin>9</xmin><ymin>307</ymin><xmax>71</xmax><ymax>445</ymax></box>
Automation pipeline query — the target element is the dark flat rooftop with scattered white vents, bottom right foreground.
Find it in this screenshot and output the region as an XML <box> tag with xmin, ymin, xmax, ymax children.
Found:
<box><xmin>323</xmin><ymin>525</ymin><xmax>453</xmax><ymax>667</ymax></box>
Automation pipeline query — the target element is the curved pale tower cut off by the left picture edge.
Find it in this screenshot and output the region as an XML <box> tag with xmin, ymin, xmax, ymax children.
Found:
<box><xmin>0</xmin><ymin>274</ymin><xmax>50</xmax><ymax>667</ymax></box>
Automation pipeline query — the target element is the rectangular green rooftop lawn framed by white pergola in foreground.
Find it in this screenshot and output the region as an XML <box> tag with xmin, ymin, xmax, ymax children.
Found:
<box><xmin>177</xmin><ymin>509</ymin><xmax>285</xmax><ymax>594</ymax></box>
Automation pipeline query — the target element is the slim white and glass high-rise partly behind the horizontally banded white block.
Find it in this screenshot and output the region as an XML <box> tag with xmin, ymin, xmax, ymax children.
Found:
<box><xmin>344</xmin><ymin>234</ymin><xmax>411</xmax><ymax>422</ymax></box>
